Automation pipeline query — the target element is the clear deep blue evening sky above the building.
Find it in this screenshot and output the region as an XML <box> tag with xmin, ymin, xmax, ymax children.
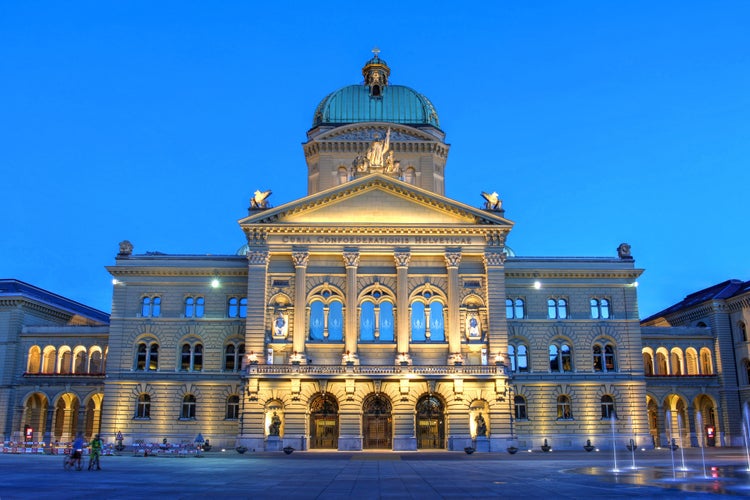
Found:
<box><xmin>0</xmin><ymin>0</ymin><xmax>750</xmax><ymax>317</ymax></box>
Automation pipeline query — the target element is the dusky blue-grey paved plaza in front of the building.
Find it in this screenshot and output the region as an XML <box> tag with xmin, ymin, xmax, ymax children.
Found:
<box><xmin>0</xmin><ymin>448</ymin><xmax>750</xmax><ymax>500</ymax></box>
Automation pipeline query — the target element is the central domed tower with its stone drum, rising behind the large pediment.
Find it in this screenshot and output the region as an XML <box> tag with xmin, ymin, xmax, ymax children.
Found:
<box><xmin>303</xmin><ymin>49</ymin><xmax>450</xmax><ymax>195</ymax></box>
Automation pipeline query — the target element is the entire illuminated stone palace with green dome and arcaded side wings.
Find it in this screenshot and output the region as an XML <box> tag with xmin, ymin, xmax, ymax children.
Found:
<box><xmin>0</xmin><ymin>51</ymin><xmax>750</xmax><ymax>452</ymax></box>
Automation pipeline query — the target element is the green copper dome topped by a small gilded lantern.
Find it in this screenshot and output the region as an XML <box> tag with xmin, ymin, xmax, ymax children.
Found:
<box><xmin>313</xmin><ymin>55</ymin><xmax>440</xmax><ymax>129</ymax></box>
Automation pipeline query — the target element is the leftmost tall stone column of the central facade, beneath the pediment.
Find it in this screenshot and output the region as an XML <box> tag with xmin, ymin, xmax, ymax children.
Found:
<box><xmin>245</xmin><ymin>249</ymin><xmax>269</xmax><ymax>363</ymax></box>
